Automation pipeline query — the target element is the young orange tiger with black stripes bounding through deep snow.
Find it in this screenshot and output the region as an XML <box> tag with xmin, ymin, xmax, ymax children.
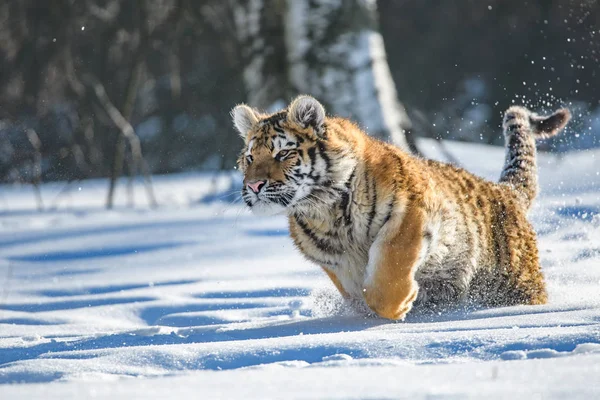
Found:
<box><xmin>232</xmin><ymin>96</ymin><xmax>570</xmax><ymax>319</ymax></box>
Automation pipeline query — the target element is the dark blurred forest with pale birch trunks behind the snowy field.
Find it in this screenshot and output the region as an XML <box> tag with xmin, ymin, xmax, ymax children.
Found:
<box><xmin>0</xmin><ymin>0</ymin><xmax>600</xmax><ymax>205</ymax></box>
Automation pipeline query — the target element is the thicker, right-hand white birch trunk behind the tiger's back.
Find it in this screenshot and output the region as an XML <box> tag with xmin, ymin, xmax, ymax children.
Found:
<box><xmin>284</xmin><ymin>0</ymin><xmax>411</xmax><ymax>151</ymax></box>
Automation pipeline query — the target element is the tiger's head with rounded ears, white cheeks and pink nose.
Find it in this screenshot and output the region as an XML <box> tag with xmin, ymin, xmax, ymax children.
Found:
<box><xmin>231</xmin><ymin>96</ymin><xmax>356</xmax><ymax>215</ymax></box>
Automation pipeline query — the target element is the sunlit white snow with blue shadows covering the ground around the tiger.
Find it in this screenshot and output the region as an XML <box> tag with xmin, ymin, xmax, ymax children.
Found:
<box><xmin>0</xmin><ymin>141</ymin><xmax>600</xmax><ymax>399</ymax></box>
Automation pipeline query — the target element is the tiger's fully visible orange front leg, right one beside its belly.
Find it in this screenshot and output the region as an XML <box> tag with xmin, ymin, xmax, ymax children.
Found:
<box><xmin>363</xmin><ymin>207</ymin><xmax>423</xmax><ymax>320</ymax></box>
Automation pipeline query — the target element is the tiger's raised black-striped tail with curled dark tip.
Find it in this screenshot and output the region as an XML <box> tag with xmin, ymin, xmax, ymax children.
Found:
<box><xmin>500</xmin><ymin>106</ymin><xmax>571</xmax><ymax>209</ymax></box>
